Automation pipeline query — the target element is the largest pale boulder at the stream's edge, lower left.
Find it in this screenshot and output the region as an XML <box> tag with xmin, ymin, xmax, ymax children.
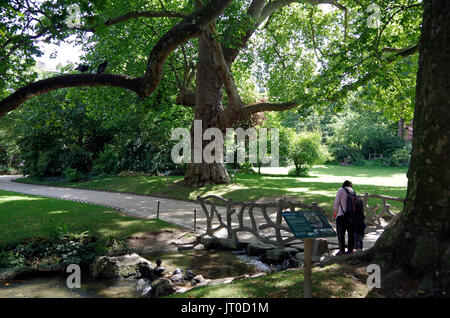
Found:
<box><xmin>91</xmin><ymin>253</ymin><xmax>151</xmax><ymax>279</ymax></box>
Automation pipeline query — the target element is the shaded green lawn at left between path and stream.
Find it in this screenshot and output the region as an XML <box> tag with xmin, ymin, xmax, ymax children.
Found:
<box><xmin>0</xmin><ymin>190</ymin><xmax>177</xmax><ymax>247</ymax></box>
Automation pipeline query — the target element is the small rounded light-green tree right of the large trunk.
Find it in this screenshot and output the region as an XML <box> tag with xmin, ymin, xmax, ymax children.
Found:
<box><xmin>289</xmin><ymin>131</ymin><xmax>329</xmax><ymax>176</ymax></box>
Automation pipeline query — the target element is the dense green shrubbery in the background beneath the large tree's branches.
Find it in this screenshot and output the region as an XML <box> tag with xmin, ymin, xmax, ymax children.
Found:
<box><xmin>0</xmin><ymin>83</ymin><xmax>411</xmax><ymax>181</ymax></box>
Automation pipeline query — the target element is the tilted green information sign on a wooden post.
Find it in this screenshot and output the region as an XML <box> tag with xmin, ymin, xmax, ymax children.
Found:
<box><xmin>281</xmin><ymin>210</ymin><xmax>337</xmax><ymax>298</ymax></box>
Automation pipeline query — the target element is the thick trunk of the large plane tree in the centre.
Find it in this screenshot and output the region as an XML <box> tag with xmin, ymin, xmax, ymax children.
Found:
<box><xmin>184</xmin><ymin>35</ymin><xmax>230</xmax><ymax>187</ymax></box>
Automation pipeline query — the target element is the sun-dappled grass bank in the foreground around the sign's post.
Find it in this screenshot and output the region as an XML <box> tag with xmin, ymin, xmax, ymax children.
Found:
<box><xmin>168</xmin><ymin>265</ymin><xmax>370</xmax><ymax>298</ymax></box>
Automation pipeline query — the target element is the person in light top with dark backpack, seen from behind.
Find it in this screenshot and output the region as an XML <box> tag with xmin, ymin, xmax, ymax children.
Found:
<box><xmin>333</xmin><ymin>180</ymin><xmax>364</xmax><ymax>255</ymax></box>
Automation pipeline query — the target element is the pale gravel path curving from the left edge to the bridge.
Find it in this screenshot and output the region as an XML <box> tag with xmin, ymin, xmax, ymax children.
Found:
<box><xmin>0</xmin><ymin>176</ymin><xmax>382</xmax><ymax>248</ymax></box>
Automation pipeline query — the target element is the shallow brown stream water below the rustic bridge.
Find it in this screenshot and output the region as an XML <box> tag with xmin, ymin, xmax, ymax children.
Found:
<box><xmin>0</xmin><ymin>250</ymin><xmax>262</xmax><ymax>298</ymax></box>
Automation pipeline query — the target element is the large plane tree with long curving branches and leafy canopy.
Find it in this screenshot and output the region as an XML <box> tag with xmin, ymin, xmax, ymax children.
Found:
<box><xmin>0</xmin><ymin>0</ymin><xmax>422</xmax><ymax>187</ymax></box>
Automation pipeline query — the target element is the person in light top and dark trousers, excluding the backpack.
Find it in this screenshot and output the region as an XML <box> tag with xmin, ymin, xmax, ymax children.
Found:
<box><xmin>333</xmin><ymin>180</ymin><xmax>355</xmax><ymax>255</ymax></box>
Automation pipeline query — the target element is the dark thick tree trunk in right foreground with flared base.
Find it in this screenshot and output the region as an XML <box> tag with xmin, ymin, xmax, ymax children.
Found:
<box><xmin>369</xmin><ymin>0</ymin><xmax>450</xmax><ymax>296</ymax></box>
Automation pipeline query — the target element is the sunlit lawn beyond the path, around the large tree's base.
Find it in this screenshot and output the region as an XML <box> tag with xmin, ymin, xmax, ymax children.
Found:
<box><xmin>15</xmin><ymin>166</ymin><xmax>407</xmax><ymax>216</ymax></box>
